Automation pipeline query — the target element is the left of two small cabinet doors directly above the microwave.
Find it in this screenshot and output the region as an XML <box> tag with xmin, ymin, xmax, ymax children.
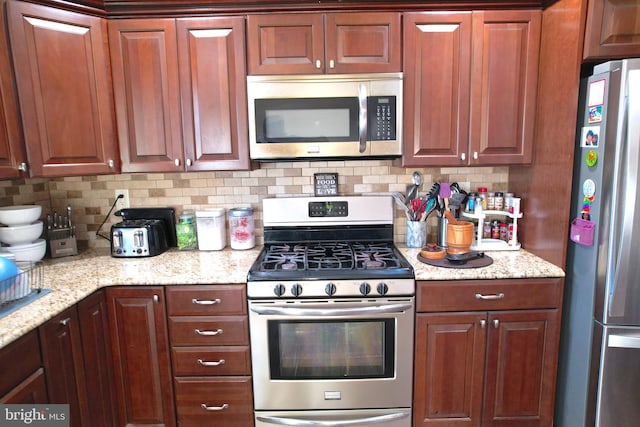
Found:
<box><xmin>247</xmin><ymin>13</ymin><xmax>325</xmax><ymax>74</ymax></box>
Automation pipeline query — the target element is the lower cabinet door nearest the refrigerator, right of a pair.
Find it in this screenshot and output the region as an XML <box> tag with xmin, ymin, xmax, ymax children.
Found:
<box><xmin>483</xmin><ymin>310</ymin><xmax>560</xmax><ymax>427</ymax></box>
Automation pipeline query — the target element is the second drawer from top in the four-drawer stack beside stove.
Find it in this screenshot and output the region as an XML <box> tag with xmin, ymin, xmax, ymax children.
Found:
<box><xmin>169</xmin><ymin>316</ymin><xmax>249</xmax><ymax>345</ymax></box>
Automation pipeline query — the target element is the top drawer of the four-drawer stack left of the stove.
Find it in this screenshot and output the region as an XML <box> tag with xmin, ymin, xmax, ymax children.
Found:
<box><xmin>166</xmin><ymin>285</ymin><xmax>247</xmax><ymax>316</ymax></box>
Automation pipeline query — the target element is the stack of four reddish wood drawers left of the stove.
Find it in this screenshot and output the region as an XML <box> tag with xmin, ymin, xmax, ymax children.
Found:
<box><xmin>166</xmin><ymin>285</ymin><xmax>253</xmax><ymax>427</ymax></box>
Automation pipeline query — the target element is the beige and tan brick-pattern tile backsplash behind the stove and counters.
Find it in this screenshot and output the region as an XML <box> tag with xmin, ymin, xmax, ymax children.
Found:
<box><xmin>0</xmin><ymin>160</ymin><xmax>509</xmax><ymax>249</ymax></box>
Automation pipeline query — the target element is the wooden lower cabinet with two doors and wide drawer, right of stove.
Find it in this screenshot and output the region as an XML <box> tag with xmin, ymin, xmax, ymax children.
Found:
<box><xmin>413</xmin><ymin>279</ymin><xmax>562</xmax><ymax>427</ymax></box>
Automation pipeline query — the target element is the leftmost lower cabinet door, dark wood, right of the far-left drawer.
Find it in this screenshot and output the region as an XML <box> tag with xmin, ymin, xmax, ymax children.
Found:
<box><xmin>39</xmin><ymin>306</ymin><xmax>91</xmax><ymax>427</ymax></box>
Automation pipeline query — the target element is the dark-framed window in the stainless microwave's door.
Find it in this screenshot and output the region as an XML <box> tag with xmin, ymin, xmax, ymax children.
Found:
<box><xmin>255</xmin><ymin>98</ymin><xmax>358</xmax><ymax>143</ymax></box>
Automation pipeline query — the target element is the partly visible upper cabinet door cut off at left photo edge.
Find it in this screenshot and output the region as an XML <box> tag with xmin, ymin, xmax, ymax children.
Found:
<box><xmin>0</xmin><ymin>0</ymin><xmax>27</xmax><ymax>179</ymax></box>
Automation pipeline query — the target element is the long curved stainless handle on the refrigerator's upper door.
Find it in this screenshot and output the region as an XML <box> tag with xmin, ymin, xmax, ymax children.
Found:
<box><xmin>609</xmin><ymin>70</ymin><xmax>640</xmax><ymax>317</ymax></box>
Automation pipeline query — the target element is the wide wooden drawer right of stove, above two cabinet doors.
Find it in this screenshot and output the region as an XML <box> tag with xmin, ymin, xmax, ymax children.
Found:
<box><xmin>416</xmin><ymin>278</ymin><xmax>563</xmax><ymax>312</ymax></box>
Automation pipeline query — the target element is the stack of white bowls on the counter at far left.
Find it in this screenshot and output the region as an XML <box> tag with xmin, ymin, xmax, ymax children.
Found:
<box><xmin>0</xmin><ymin>205</ymin><xmax>47</xmax><ymax>261</ymax></box>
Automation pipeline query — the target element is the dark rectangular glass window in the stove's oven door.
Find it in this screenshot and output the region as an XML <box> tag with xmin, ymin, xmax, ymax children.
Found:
<box><xmin>269</xmin><ymin>319</ymin><xmax>395</xmax><ymax>380</ymax></box>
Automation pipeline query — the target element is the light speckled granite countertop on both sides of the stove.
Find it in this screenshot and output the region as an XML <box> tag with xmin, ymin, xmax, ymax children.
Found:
<box><xmin>0</xmin><ymin>247</ymin><xmax>564</xmax><ymax>348</ymax></box>
